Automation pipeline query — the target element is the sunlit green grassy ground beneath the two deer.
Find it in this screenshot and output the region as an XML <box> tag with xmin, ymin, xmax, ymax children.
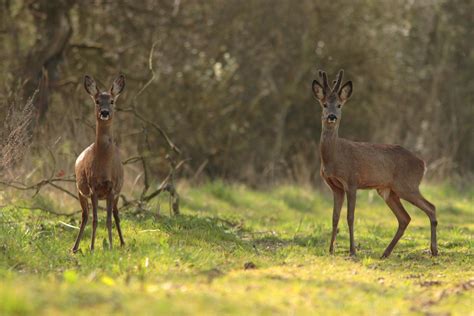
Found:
<box><xmin>0</xmin><ymin>182</ymin><xmax>474</xmax><ymax>315</ymax></box>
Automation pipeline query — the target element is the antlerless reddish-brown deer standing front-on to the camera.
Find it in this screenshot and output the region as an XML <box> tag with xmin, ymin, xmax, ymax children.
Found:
<box><xmin>72</xmin><ymin>75</ymin><xmax>125</xmax><ymax>252</ymax></box>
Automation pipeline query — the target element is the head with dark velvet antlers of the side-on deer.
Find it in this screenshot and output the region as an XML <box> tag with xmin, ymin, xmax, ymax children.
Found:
<box><xmin>313</xmin><ymin>69</ymin><xmax>352</xmax><ymax>128</ymax></box>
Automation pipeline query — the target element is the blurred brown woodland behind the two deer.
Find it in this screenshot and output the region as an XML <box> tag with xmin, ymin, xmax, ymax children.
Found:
<box><xmin>0</xmin><ymin>0</ymin><xmax>474</xmax><ymax>186</ymax></box>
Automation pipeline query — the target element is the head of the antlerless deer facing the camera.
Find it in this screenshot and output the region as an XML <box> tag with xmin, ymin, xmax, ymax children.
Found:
<box><xmin>84</xmin><ymin>75</ymin><xmax>125</xmax><ymax>122</ymax></box>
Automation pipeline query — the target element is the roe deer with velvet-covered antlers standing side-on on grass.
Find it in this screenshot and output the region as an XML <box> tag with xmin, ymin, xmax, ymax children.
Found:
<box><xmin>312</xmin><ymin>70</ymin><xmax>438</xmax><ymax>258</ymax></box>
